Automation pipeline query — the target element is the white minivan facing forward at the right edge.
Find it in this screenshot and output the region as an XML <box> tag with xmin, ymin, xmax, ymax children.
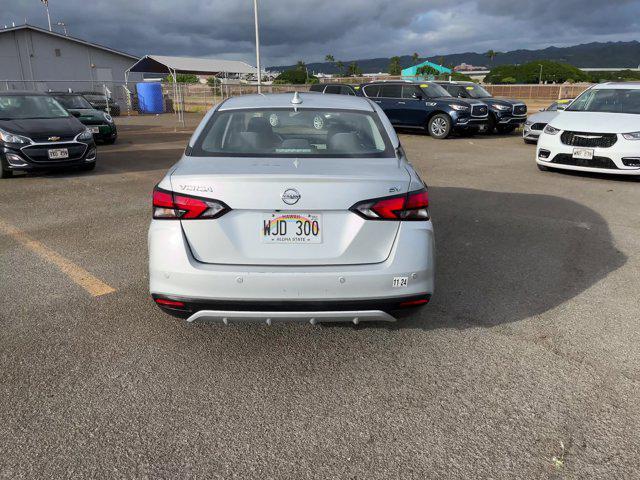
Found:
<box><xmin>536</xmin><ymin>82</ymin><xmax>640</xmax><ymax>175</ymax></box>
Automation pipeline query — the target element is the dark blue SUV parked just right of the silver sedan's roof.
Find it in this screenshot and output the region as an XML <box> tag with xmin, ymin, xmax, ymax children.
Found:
<box><xmin>360</xmin><ymin>81</ymin><xmax>488</xmax><ymax>139</ymax></box>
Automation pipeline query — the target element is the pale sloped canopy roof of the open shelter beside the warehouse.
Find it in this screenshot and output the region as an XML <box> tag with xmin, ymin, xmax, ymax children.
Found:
<box><xmin>130</xmin><ymin>55</ymin><xmax>256</xmax><ymax>75</ymax></box>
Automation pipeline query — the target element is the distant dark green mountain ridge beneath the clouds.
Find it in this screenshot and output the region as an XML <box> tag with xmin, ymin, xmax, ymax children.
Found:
<box><xmin>268</xmin><ymin>40</ymin><xmax>640</xmax><ymax>73</ymax></box>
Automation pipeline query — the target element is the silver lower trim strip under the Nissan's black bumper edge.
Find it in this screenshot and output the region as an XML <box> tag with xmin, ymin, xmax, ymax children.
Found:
<box><xmin>187</xmin><ymin>310</ymin><xmax>396</xmax><ymax>325</ymax></box>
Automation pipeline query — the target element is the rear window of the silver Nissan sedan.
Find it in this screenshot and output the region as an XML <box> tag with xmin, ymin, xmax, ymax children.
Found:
<box><xmin>191</xmin><ymin>108</ymin><xmax>395</xmax><ymax>158</ymax></box>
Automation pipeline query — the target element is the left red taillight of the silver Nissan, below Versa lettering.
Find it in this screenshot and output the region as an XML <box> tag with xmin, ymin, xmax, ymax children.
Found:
<box><xmin>153</xmin><ymin>187</ymin><xmax>231</xmax><ymax>220</ymax></box>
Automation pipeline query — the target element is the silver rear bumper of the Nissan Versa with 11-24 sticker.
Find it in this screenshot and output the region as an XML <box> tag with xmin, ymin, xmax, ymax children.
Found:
<box><xmin>149</xmin><ymin>220</ymin><xmax>435</xmax><ymax>321</ymax></box>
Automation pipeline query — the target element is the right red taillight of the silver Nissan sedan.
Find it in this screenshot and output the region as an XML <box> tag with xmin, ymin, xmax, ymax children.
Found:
<box><xmin>350</xmin><ymin>188</ymin><xmax>429</xmax><ymax>221</ymax></box>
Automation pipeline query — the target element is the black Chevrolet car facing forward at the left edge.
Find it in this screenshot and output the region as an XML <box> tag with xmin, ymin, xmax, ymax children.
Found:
<box><xmin>0</xmin><ymin>92</ymin><xmax>96</xmax><ymax>178</ymax></box>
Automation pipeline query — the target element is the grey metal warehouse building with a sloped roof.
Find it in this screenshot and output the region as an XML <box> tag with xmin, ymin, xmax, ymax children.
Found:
<box><xmin>0</xmin><ymin>25</ymin><xmax>142</xmax><ymax>91</ymax></box>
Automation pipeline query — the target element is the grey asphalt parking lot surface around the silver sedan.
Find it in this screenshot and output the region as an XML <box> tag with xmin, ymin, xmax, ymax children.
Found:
<box><xmin>0</xmin><ymin>113</ymin><xmax>640</xmax><ymax>479</ymax></box>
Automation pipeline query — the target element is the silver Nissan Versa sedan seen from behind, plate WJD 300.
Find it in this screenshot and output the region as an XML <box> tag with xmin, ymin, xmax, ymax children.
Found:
<box><xmin>149</xmin><ymin>93</ymin><xmax>434</xmax><ymax>324</ymax></box>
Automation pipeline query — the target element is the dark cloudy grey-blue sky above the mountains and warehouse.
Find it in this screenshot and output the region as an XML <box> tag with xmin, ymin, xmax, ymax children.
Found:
<box><xmin>5</xmin><ymin>0</ymin><xmax>640</xmax><ymax>65</ymax></box>
